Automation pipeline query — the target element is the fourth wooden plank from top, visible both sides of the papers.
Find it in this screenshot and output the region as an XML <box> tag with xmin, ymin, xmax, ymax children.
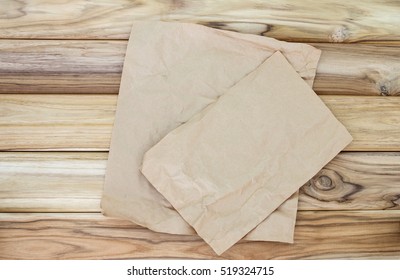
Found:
<box><xmin>0</xmin><ymin>152</ymin><xmax>400</xmax><ymax>212</ymax></box>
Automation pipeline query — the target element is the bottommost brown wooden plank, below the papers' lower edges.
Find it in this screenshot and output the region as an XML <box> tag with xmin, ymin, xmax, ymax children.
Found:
<box><xmin>0</xmin><ymin>210</ymin><xmax>400</xmax><ymax>259</ymax></box>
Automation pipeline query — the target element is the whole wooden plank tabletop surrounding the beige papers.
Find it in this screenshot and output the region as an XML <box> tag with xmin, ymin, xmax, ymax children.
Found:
<box><xmin>0</xmin><ymin>0</ymin><xmax>400</xmax><ymax>259</ymax></box>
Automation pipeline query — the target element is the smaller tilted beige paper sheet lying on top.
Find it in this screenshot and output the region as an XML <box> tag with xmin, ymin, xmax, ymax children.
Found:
<box><xmin>142</xmin><ymin>52</ymin><xmax>352</xmax><ymax>254</ymax></box>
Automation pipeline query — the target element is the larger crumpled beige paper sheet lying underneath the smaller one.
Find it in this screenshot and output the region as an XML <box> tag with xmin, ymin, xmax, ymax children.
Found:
<box><xmin>101</xmin><ymin>22</ymin><xmax>320</xmax><ymax>242</ymax></box>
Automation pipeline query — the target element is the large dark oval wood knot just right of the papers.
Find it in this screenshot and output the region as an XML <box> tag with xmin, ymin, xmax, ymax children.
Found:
<box><xmin>301</xmin><ymin>168</ymin><xmax>362</xmax><ymax>202</ymax></box>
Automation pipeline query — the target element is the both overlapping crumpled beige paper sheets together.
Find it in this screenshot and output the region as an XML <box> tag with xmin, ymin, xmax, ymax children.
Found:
<box><xmin>102</xmin><ymin>21</ymin><xmax>351</xmax><ymax>254</ymax></box>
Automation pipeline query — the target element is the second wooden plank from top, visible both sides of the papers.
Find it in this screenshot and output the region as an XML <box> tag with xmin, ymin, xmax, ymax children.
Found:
<box><xmin>0</xmin><ymin>40</ymin><xmax>400</xmax><ymax>95</ymax></box>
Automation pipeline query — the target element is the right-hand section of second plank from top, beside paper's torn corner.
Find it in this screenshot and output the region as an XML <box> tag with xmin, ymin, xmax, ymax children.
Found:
<box><xmin>313</xmin><ymin>44</ymin><xmax>400</xmax><ymax>96</ymax></box>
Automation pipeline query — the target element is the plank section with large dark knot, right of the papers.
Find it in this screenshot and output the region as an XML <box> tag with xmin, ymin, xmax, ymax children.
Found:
<box><xmin>299</xmin><ymin>152</ymin><xmax>400</xmax><ymax>210</ymax></box>
